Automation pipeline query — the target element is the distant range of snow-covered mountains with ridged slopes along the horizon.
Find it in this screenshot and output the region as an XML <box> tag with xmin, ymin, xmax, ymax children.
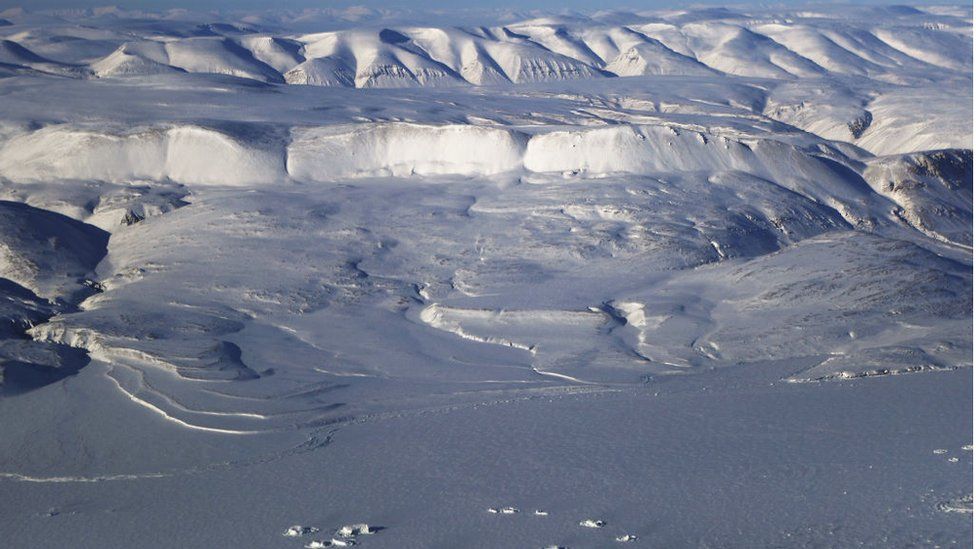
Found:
<box><xmin>3</xmin><ymin>4</ymin><xmax>972</xmax><ymax>88</ymax></box>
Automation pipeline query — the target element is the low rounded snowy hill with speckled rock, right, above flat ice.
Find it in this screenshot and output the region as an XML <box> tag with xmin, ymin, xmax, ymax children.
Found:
<box><xmin>604</xmin><ymin>233</ymin><xmax>972</xmax><ymax>381</ymax></box>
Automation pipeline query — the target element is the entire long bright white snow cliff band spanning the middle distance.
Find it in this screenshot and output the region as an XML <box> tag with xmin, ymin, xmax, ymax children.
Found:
<box><xmin>0</xmin><ymin>122</ymin><xmax>896</xmax><ymax>203</ymax></box>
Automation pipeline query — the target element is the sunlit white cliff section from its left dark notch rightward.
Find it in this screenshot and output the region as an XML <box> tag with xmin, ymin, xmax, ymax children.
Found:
<box><xmin>288</xmin><ymin>123</ymin><xmax>864</xmax><ymax>184</ymax></box>
